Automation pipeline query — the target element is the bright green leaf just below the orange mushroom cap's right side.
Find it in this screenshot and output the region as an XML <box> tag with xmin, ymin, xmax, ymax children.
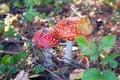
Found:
<box><xmin>76</xmin><ymin>36</ymin><xmax>90</xmax><ymax>48</ymax></box>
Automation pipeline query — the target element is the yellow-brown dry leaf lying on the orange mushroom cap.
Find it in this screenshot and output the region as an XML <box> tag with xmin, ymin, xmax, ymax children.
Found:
<box><xmin>78</xmin><ymin>16</ymin><xmax>94</xmax><ymax>34</ymax></box>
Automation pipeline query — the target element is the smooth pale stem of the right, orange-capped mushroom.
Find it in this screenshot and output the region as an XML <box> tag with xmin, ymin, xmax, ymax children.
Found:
<box><xmin>64</xmin><ymin>41</ymin><xmax>73</xmax><ymax>64</ymax></box>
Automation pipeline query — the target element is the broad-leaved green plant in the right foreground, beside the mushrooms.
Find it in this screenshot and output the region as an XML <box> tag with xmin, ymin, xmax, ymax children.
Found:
<box><xmin>76</xmin><ymin>35</ymin><xmax>120</xmax><ymax>80</ymax></box>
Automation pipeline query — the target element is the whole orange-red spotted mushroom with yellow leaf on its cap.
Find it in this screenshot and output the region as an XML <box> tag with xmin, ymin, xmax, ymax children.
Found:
<box><xmin>55</xmin><ymin>17</ymin><xmax>94</xmax><ymax>63</ymax></box>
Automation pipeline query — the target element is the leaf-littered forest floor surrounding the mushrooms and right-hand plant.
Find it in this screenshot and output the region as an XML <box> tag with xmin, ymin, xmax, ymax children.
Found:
<box><xmin>0</xmin><ymin>0</ymin><xmax>120</xmax><ymax>80</ymax></box>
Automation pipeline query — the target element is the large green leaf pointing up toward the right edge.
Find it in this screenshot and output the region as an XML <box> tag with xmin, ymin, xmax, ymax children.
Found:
<box><xmin>98</xmin><ymin>35</ymin><xmax>116</xmax><ymax>52</ymax></box>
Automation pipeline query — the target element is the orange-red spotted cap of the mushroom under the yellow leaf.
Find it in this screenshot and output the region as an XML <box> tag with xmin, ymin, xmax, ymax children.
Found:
<box><xmin>55</xmin><ymin>17</ymin><xmax>82</xmax><ymax>41</ymax></box>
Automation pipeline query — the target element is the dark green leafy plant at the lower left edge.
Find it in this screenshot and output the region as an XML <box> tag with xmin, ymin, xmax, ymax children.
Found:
<box><xmin>0</xmin><ymin>51</ymin><xmax>28</xmax><ymax>78</ymax></box>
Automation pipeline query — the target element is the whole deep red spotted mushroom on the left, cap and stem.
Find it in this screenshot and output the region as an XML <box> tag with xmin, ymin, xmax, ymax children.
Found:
<box><xmin>33</xmin><ymin>29</ymin><xmax>59</xmax><ymax>68</ymax></box>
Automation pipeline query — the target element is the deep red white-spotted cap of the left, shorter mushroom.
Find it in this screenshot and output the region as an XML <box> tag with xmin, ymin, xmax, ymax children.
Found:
<box><xmin>33</xmin><ymin>29</ymin><xmax>59</xmax><ymax>49</ymax></box>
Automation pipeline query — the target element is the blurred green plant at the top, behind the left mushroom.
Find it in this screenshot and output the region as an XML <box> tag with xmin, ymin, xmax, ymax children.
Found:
<box><xmin>22</xmin><ymin>0</ymin><xmax>51</xmax><ymax>22</ymax></box>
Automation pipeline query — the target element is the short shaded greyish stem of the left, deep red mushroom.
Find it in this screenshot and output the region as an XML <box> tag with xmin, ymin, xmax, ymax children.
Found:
<box><xmin>45</xmin><ymin>48</ymin><xmax>53</xmax><ymax>65</ymax></box>
